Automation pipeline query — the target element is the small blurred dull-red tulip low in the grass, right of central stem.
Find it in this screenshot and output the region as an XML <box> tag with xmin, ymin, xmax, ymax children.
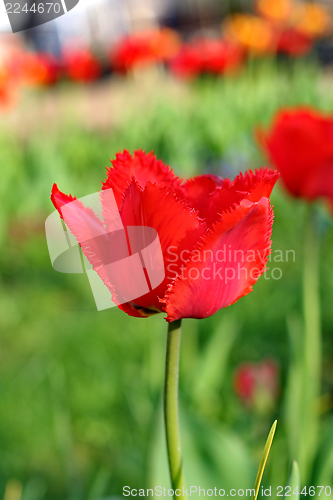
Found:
<box><xmin>234</xmin><ymin>360</ymin><xmax>279</xmax><ymax>412</ymax></box>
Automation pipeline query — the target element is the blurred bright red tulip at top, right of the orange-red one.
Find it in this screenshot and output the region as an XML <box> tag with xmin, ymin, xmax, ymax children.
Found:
<box><xmin>171</xmin><ymin>38</ymin><xmax>244</xmax><ymax>78</ymax></box>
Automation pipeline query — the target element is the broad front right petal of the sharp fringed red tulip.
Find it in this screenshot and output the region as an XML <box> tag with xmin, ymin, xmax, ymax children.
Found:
<box><xmin>162</xmin><ymin>198</ymin><xmax>273</xmax><ymax>322</ymax></box>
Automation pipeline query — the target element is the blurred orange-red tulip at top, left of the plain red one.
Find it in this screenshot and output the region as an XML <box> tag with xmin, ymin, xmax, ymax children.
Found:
<box><xmin>110</xmin><ymin>28</ymin><xmax>180</xmax><ymax>72</ymax></box>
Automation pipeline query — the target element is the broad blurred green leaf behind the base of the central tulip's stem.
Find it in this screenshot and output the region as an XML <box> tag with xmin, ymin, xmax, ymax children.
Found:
<box><xmin>148</xmin><ymin>405</ymin><xmax>253</xmax><ymax>490</ymax></box>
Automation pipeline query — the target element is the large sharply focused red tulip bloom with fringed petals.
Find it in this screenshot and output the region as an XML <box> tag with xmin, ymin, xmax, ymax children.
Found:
<box><xmin>51</xmin><ymin>151</ymin><xmax>278</xmax><ymax>322</ymax></box>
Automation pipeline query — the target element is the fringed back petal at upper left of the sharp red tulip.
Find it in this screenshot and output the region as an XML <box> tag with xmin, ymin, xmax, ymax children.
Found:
<box><xmin>103</xmin><ymin>151</ymin><xmax>181</xmax><ymax>209</ymax></box>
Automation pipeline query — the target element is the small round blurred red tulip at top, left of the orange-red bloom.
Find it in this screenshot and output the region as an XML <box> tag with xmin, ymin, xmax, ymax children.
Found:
<box><xmin>63</xmin><ymin>49</ymin><xmax>102</xmax><ymax>82</ymax></box>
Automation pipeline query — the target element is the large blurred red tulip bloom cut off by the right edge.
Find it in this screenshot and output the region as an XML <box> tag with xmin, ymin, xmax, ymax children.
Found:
<box><xmin>257</xmin><ymin>108</ymin><xmax>333</xmax><ymax>203</ymax></box>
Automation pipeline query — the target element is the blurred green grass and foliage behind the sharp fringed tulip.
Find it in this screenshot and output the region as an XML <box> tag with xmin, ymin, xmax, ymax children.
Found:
<box><xmin>0</xmin><ymin>59</ymin><xmax>333</xmax><ymax>500</ymax></box>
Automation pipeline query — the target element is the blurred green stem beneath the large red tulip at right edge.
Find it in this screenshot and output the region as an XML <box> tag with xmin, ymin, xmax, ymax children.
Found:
<box><xmin>300</xmin><ymin>207</ymin><xmax>322</xmax><ymax>478</ymax></box>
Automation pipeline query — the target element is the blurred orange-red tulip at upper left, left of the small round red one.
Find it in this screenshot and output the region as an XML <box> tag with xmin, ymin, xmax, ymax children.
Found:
<box><xmin>18</xmin><ymin>52</ymin><xmax>59</xmax><ymax>85</ymax></box>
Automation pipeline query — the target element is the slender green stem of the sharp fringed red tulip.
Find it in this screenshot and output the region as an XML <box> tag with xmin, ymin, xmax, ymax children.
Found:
<box><xmin>164</xmin><ymin>320</ymin><xmax>187</xmax><ymax>499</ymax></box>
